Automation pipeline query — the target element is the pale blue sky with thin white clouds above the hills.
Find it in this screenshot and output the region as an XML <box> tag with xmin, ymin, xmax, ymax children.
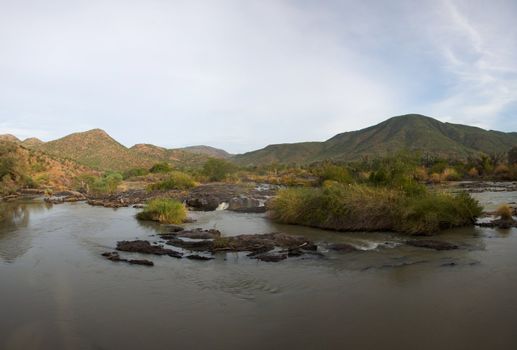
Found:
<box><xmin>0</xmin><ymin>0</ymin><xmax>517</xmax><ymax>153</ymax></box>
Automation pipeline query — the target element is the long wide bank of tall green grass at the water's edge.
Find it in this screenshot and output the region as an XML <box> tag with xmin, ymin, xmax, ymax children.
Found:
<box><xmin>271</xmin><ymin>182</ymin><xmax>481</xmax><ymax>234</ymax></box>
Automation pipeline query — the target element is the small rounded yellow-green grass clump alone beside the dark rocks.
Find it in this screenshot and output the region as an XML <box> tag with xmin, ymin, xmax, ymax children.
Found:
<box><xmin>136</xmin><ymin>198</ymin><xmax>187</xmax><ymax>224</ymax></box>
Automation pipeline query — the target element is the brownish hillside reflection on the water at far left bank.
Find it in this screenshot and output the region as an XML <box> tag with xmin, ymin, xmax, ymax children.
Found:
<box><xmin>0</xmin><ymin>200</ymin><xmax>52</xmax><ymax>262</ymax></box>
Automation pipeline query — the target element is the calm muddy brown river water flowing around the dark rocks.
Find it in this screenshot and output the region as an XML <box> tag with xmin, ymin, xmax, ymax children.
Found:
<box><xmin>0</xmin><ymin>193</ymin><xmax>517</xmax><ymax>350</ymax></box>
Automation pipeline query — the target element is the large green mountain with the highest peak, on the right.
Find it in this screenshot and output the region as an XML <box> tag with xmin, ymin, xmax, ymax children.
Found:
<box><xmin>234</xmin><ymin>114</ymin><xmax>517</xmax><ymax>165</ymax></box>
